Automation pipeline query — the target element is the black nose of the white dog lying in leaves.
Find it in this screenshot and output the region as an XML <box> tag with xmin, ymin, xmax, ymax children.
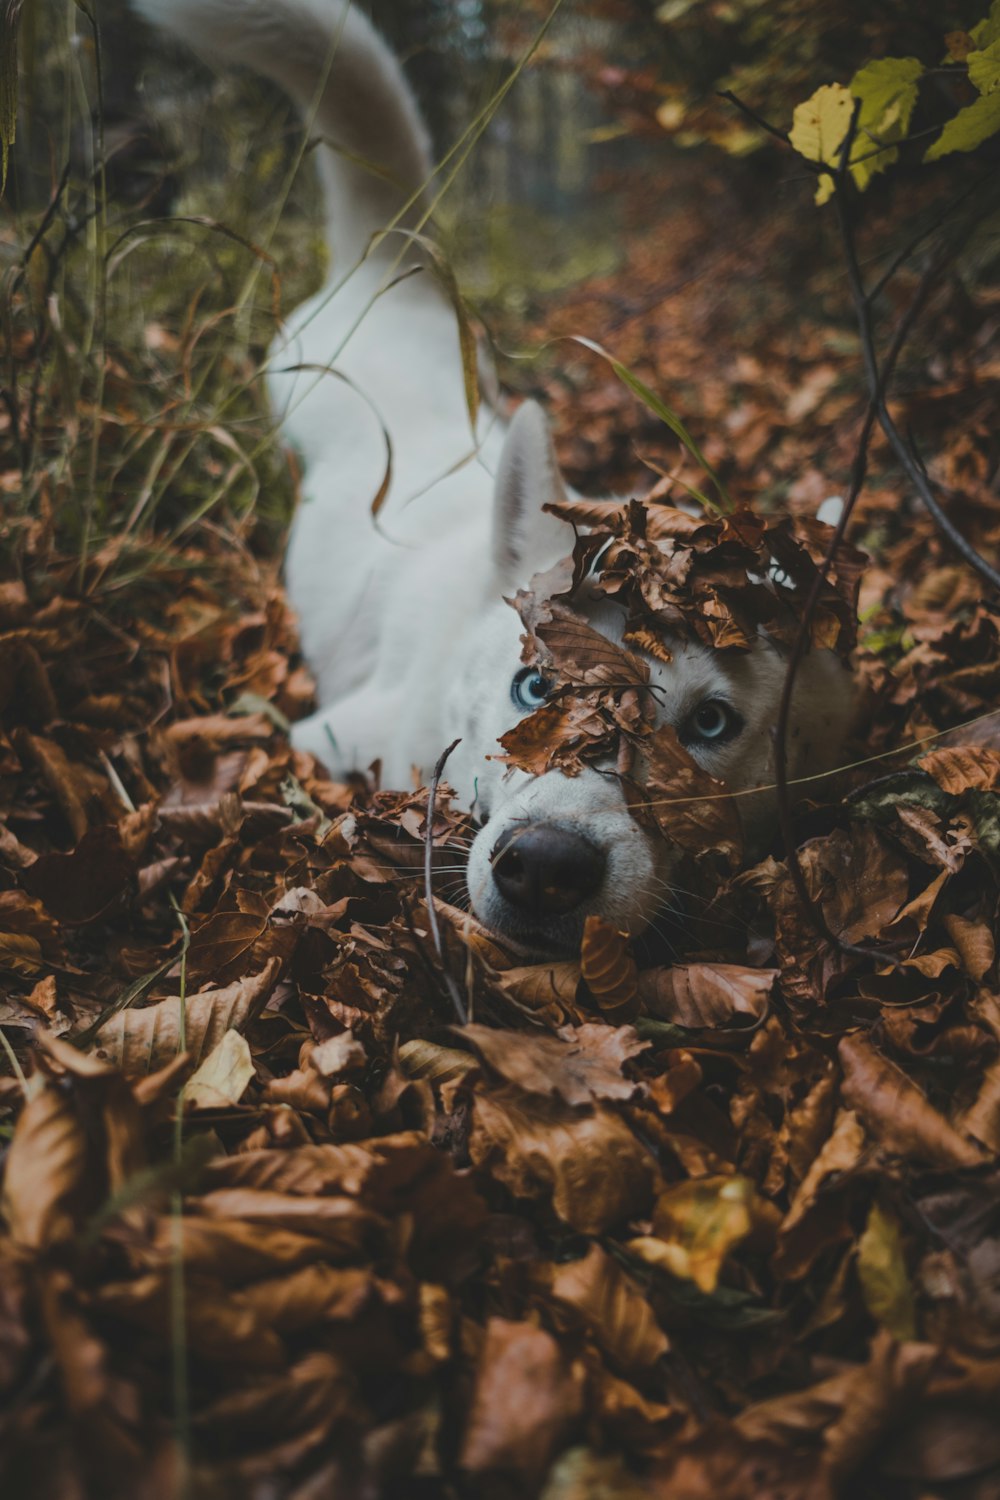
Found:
<box><xmin>492</xmin><ymin>824</ymin><xmax>606</xmax><ymax>917</ymax></box>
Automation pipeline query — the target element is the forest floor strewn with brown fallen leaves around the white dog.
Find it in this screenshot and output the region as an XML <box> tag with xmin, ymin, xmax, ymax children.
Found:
<box><xmin>0</xmin><ymin>14</ymin><xmax>1000</xmax><ymax>1500</ymax></box>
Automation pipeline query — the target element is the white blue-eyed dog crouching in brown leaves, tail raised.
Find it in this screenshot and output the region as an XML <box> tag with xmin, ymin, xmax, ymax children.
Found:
<box><xmin>136</xmin><ymin>0</ymin><xmax>852</xmax><ymax>951</ymax></box>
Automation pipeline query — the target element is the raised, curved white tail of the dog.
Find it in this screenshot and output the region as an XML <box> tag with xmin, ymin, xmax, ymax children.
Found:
<box><xmin>133</xmin><ymin>0</ymin><xmax>432</xmax><ymax>275</ymax></box>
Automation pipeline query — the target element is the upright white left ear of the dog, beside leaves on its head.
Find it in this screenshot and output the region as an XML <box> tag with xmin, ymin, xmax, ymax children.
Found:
<box><xmin>493</xmin><ymin>401</ymin><xmax>573</xmax><ymax>591</ymax></box>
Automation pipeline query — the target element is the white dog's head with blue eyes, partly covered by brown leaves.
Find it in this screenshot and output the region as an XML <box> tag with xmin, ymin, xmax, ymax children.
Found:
<box><xmin>445</xmin><ymin>404</ymin><xmax>852</xmax><ymax>953</ymax></box>
